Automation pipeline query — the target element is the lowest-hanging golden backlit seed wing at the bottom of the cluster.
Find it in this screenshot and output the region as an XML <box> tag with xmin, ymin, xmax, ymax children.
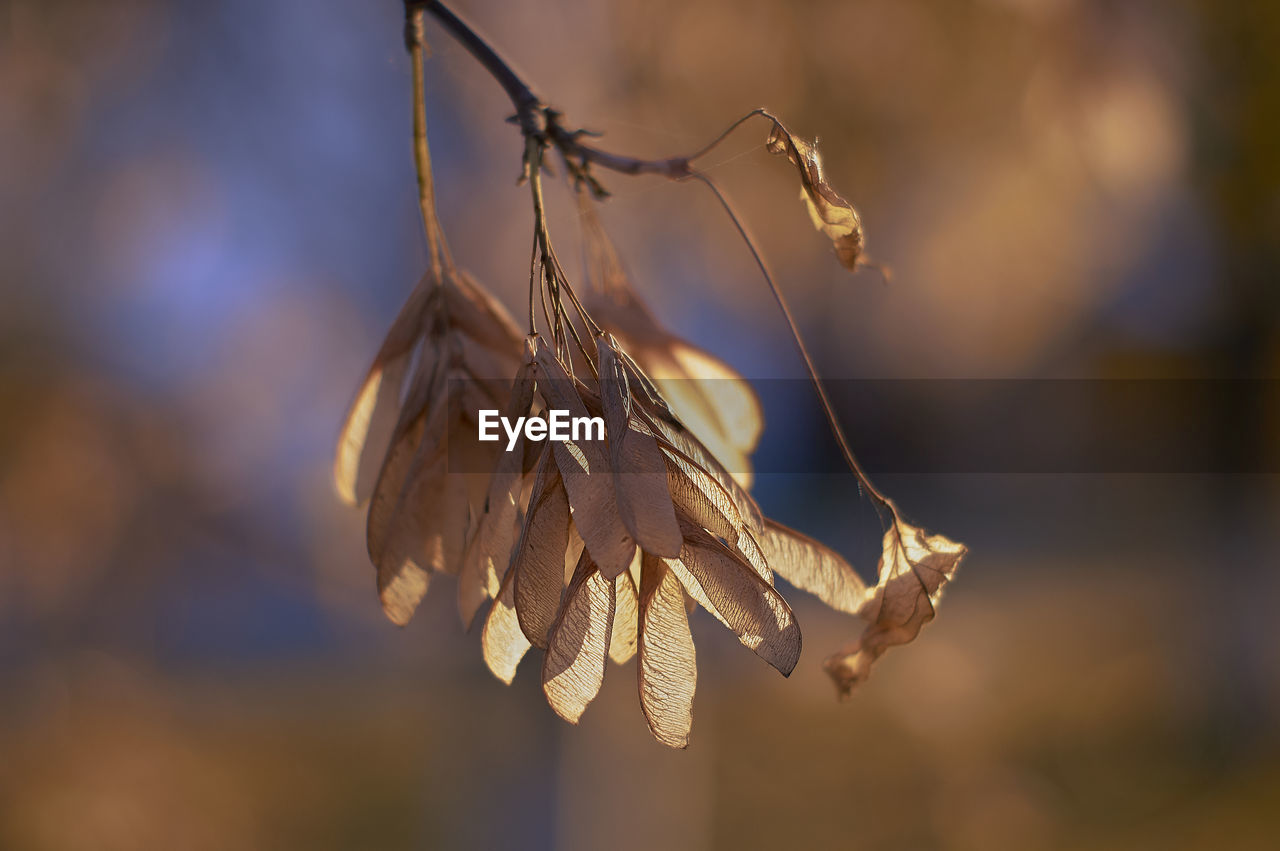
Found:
<box><xmin>636</xmin><ymin>555</ymin><xmax>698</xmax><ymax>747</ymax></box>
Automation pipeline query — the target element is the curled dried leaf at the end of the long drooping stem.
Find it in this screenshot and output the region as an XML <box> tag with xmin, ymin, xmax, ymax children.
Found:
<box><xmin>824</xmin><ymin>512</ymin><xmax>968</xmax><ymax>696</ymax></box>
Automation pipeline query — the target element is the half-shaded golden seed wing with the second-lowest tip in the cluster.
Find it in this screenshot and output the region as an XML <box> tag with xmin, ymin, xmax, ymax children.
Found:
<box><xmin>543</xmin><ymin>550</ymin><xmax>616</xmax><ymax>724</ymax></box>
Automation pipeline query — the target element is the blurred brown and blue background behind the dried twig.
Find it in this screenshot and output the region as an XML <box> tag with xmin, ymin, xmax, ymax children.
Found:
<box><xmin>0</xmin><ymin>0</ymin><xmax>1280</xmax><ymax>850</ymax></box>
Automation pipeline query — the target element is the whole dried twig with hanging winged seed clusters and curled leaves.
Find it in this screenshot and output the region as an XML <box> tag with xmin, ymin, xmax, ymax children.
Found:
<box><xmin>334</xmin><ymin>0</ymin><xmax>965</xmax><ymax>747</ymax></box>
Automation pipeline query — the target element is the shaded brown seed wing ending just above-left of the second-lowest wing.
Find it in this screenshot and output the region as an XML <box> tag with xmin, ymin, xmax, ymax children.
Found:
<box><xmin>511</xmin><ymin>449</ymin><xmax>570</xmax><ymax>649</ymax></box>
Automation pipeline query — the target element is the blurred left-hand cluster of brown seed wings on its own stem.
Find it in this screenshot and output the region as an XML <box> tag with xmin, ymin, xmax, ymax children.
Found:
<box><xmin>334</xmin><ymin>270</ymin><xmax>521</xmax><ymax>624</ymax></box>
